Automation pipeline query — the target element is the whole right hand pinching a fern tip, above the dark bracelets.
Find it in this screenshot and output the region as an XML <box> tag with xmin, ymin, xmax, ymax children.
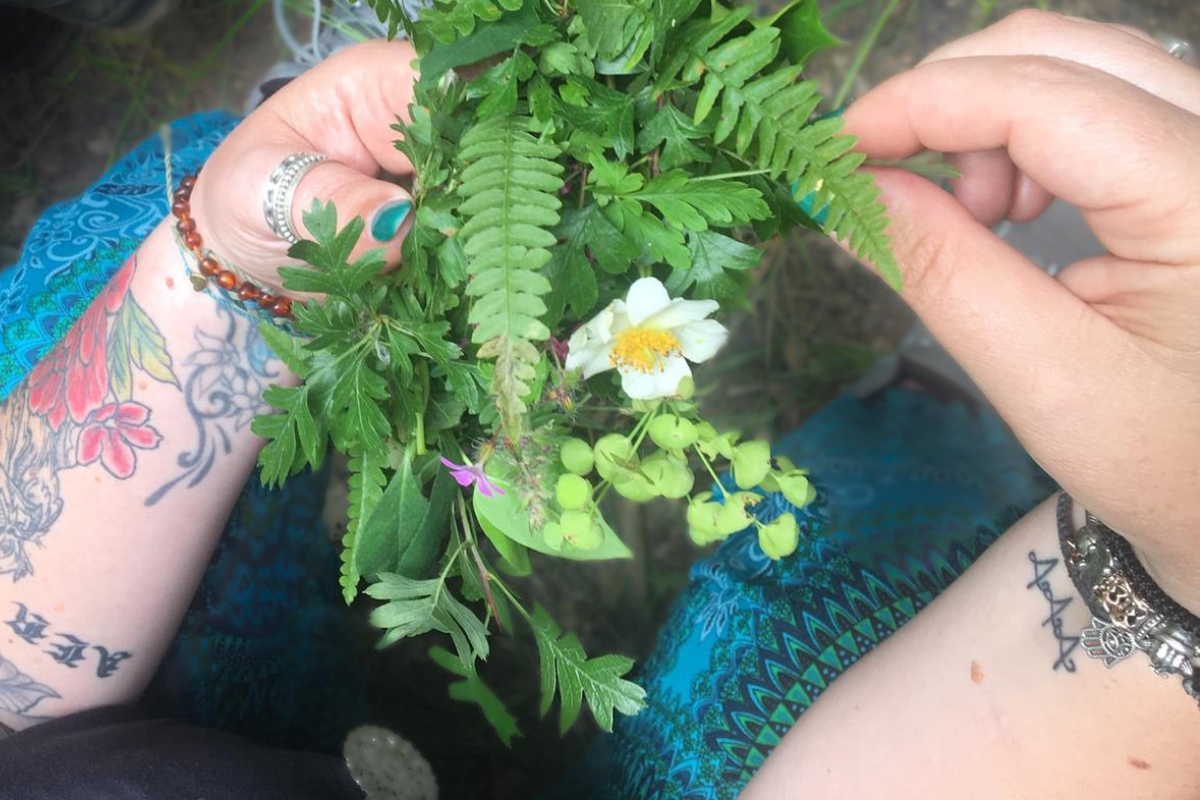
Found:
<box><xmin>845</xmin><ymin>12</ymin><xmax>1200</xmax><ymax>610</ymax></box>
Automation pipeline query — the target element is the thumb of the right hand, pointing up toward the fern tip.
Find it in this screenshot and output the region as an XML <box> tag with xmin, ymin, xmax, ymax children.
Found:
<box><xmin>871</xmin><ymin>169</ymin><xmax>1120</xmax><ymax>448</ymax></box>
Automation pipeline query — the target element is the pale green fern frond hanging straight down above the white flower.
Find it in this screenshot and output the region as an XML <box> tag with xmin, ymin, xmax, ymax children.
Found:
<box><xmin>458</xmin><ymin>115</ymin><xmax>563</xmax><ymax>437</ymax></box>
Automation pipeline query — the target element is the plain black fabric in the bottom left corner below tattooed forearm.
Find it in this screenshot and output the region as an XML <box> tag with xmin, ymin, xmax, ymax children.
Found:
<box><xmin>0</xmin><ymin>706</ymin><xmax>364</xmax><ymax>800</ymax></box>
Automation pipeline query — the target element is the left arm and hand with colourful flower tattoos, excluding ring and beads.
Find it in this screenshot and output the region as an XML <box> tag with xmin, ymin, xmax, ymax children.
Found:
<box><xmin>0</xmin><ymin>42</ymin><xmax>422</xmax><ymax>728</ymax></box>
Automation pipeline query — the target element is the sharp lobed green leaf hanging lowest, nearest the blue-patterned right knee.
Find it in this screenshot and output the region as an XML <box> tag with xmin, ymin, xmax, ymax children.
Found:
<box><xmin>530</xmin><ymin>606</ymin><xmax>646</xmax><ymax>733</ymax></box>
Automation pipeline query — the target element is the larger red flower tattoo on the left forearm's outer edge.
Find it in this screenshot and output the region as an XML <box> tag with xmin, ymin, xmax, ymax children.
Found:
<box><xmin>29</xmin><ymin>258</ymin><xmax>133</xmax><ymax>431</ymax></box>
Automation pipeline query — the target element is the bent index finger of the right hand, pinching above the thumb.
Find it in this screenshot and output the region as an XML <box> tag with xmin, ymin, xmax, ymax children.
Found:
<box><xmin>845</xmin><ymin>56</ymin><xmax>1200</xmax><ymax>264</ymax></box>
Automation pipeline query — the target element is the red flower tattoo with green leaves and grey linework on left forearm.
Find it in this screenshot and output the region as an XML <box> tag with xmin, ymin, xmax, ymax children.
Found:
<box><xmin>0</xmin><ymin>255</ymin><xmax>179</xmax><ymax>581</ymax></box>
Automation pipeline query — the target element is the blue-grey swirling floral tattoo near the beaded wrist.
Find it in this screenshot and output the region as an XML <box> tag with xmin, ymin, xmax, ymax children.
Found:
<box><xmin>145</xmin><ymin>306</ymin><xmax>282</xmax><ymax>506</ymax></box>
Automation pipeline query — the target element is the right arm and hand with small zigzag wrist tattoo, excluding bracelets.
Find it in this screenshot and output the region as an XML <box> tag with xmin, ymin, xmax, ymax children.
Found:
<box><xmin>746</xmin><ymin>13</ymin><xmax>1200</xmax><ymax>800</ymax></box>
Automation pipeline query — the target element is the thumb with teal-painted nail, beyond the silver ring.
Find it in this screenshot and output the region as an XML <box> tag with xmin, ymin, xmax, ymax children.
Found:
<box><xmin>292</xmin><ymin>161</ymin><xmax>413</xmax><ymax>266</ymax></box>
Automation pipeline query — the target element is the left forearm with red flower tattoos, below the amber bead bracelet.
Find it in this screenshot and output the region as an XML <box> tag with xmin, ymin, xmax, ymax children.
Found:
<box><xmin>0</xmin><ymin>218</ymin><xmax>293</xmax><ymax>728</ymax></box>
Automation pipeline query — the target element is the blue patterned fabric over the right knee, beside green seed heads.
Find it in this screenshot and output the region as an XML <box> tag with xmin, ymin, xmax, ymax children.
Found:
<box><xmin>547</xmin><ymin>389</ymin><xmax>1054</xmax><ymax>800</ymax></box>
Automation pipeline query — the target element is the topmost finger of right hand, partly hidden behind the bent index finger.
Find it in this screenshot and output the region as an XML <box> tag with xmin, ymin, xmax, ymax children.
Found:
<box><xmin>922</xmin><ymin>10</ymin><xmax>1200</xmax><ymax>114</ymax></box>
